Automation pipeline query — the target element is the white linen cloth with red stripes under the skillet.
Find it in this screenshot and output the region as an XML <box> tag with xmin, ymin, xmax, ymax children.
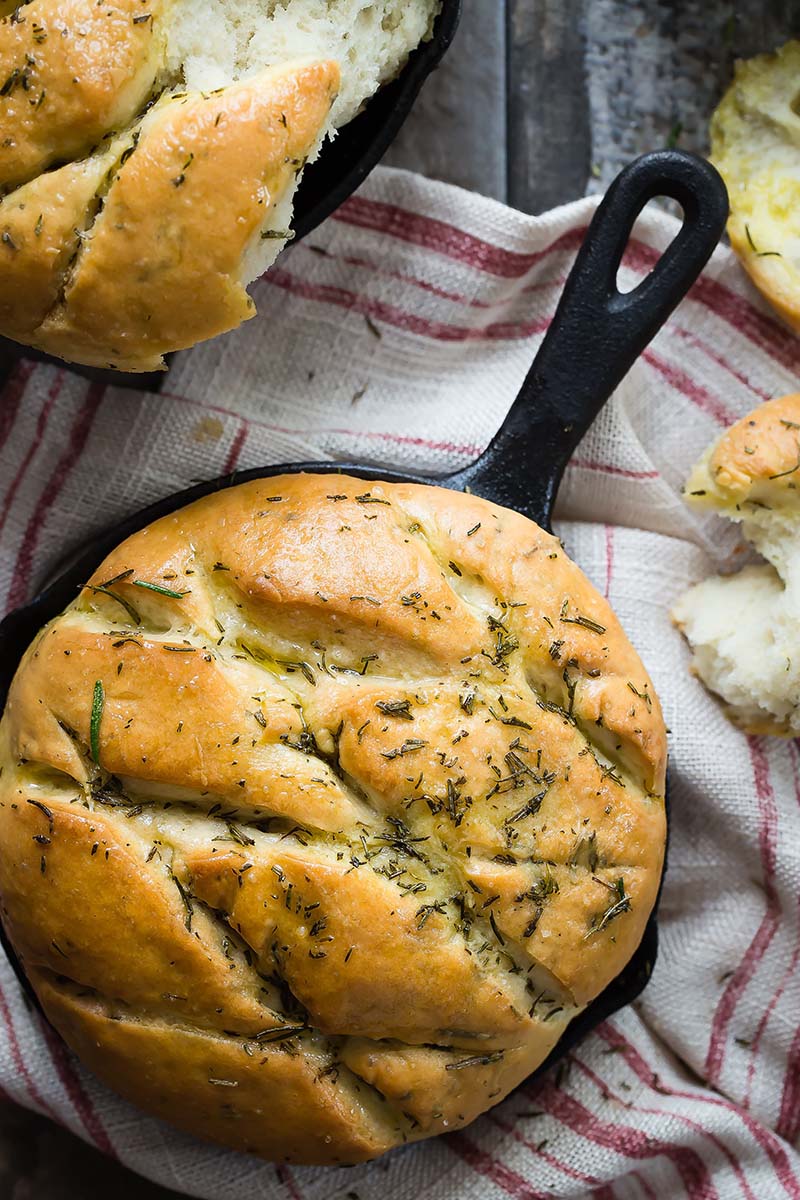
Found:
<box><xmin>0</xmin><ymin>169</ymin><xmax>800</xmax><ymax>1200</ymax></box>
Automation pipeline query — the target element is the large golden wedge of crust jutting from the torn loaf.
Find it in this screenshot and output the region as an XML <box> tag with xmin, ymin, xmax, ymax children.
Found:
<box><xmin>35</xmin><ymin>62</ymin><xmax>338</xmax><ymax>371</ymax></box>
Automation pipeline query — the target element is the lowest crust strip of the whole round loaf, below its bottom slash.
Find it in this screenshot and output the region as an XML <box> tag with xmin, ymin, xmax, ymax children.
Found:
<box><xmin>41</xmin><ymin>982</ymin><xmax>400</xmax><ymax>1163</ymax></box>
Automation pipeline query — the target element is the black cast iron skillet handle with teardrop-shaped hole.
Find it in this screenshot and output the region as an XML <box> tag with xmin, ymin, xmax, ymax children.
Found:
<box><xmin>445</xmin><ymin>150</ymin><xmax>728</xmax><ymax>527</ymax></box>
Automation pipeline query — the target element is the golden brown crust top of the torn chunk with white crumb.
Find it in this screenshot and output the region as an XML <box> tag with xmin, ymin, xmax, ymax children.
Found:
<box><xmin>685</xmin><ymin>392</ymin><xmax>800</xmax><ymax>509</ymax></box>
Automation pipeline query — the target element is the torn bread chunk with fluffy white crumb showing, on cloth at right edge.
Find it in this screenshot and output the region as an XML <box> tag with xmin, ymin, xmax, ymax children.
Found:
<box><xmin>674</xmin><ymin>394</ymin><xmax>800</xmax><ymax>738</ymax></box>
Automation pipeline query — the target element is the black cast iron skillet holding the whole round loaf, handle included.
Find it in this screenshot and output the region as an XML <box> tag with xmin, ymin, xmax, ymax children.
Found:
<box><xmin>0</xmin><ymin>150</ymin><xmax>728</xmax><ymax>1070</ymax></box>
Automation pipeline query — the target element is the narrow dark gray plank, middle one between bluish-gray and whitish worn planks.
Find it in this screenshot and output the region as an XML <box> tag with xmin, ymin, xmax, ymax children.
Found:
<box><xmin>509</xmin><ymin>0</ymin><xmax>593</xmax><ymax>212</ymax></box>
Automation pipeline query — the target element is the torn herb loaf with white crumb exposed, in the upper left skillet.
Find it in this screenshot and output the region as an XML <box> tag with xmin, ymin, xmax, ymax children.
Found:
<box><xmin>0</xmin><ymin>0</ymin><xmax>440</xmax><ymax>372</ymax></box>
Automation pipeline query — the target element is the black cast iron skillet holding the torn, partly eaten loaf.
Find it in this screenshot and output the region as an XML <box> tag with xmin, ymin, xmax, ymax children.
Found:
<box><xmin>0</xmin><ymin>0</ymin><xmax>462</xmax><ymax>391</ymax></box>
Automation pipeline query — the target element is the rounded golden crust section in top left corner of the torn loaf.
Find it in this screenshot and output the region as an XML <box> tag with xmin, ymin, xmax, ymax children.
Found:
<box><xmin>0</xmin><ymin>0</ymin><xmax>168</xmax><ymax>191</ymax></box>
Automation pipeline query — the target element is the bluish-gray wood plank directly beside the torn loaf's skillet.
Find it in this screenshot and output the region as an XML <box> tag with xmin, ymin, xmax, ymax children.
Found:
<box><xmin>386</xmin><ymin>0</ymin><xmax>506</xmax><ymax>200</ymax></box>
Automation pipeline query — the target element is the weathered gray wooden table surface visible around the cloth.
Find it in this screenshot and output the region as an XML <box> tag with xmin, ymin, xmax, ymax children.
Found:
<box><xmin>0</xmin><ymin>0</ymin><xmax>800</xmax><ymax>1200</ymax></box>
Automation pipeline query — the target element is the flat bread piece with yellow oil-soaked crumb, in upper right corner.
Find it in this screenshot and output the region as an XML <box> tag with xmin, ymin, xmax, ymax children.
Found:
<box><xmin>711</xmin><ymin>41</ymin><xmax>800</xmax><ymax>331</ymax></box>
